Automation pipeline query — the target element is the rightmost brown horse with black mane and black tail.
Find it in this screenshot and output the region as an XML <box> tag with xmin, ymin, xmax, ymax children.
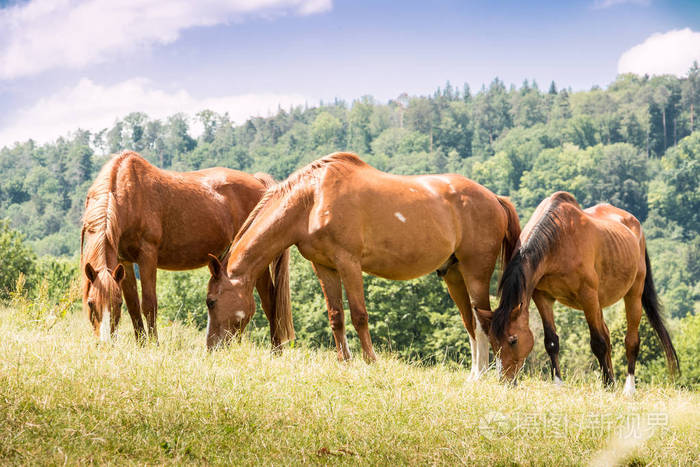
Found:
<box><xmin>478</xmin><ymin>192</ymin><xmax>678</xmax><ymax>395</ymax></box>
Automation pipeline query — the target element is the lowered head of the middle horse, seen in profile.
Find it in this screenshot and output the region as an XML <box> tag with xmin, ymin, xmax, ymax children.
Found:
<box><xmin>207</xmin><ymin>255</ymin><xmax>255</xmax><ymax>350</ymax></box>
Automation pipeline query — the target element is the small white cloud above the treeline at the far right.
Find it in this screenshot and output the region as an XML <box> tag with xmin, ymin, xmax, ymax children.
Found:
<box><xmin>617</xmin><ymin>28</ymin><xmax>700</xmax><ymax>76</ymax></box>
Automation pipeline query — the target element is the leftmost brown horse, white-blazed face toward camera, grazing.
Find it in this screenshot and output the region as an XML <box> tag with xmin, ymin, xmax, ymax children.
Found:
<box><xmin>81</xmin><ymin>152</ymin><xmax>294</xmax><ymax>345</ymax></box>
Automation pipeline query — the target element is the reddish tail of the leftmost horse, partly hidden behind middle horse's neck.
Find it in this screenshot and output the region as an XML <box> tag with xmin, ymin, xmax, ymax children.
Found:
<box><xmin>254</xmin><ymin>172</ymin><xmax>294</xmax><ymax>344</ymax></box>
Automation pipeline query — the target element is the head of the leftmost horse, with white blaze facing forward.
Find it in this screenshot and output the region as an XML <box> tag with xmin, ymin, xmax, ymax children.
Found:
<box><xmin>83</xmin><ymin>263</ymin><xmax>125</xmax><ymax>341</ymax></box>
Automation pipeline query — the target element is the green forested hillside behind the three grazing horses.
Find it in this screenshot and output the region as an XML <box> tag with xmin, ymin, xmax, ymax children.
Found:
<box><xmin>0</xmin><ymin>68</ymin><xmax>700</xmax><ymax>387</ymax></box>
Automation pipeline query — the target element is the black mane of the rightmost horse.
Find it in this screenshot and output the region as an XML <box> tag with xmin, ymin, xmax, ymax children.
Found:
<box><xmin>491</xmin><ymin>192</ymin><xmax>580</xmax><ymax>337</ymax></box>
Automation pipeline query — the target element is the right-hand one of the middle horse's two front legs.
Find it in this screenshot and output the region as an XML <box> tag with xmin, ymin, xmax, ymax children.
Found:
<box><xmin>336</xmin><ymin>258</ymin><xmax>377</xmax><ymax>363</ymax></box>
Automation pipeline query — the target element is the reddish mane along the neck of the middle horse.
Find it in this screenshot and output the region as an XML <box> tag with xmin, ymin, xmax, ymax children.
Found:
<box><xmin>231</xmin><ymin>152</ymin><xmax>366</xmax><ymax>245</ymax></box>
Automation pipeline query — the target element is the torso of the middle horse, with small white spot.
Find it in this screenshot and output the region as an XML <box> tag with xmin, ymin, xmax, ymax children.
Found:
<box><xmin>302</xmin><ymin>164</ymin><xmax>507</xmax><ymax>279</ymax></box>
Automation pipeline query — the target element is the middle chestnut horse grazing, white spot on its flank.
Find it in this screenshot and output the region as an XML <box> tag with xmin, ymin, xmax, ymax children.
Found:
<box><xmin>208</xmin><ymin>153</ymin><xmax>520</xmax><ymax>377</ymax></box>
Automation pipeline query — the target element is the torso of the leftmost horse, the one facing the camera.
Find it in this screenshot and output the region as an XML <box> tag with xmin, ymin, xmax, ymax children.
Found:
<box><xmin>88</xmin><ymin>152</ymin><xmax>265</xmax><ymax>269</ymax></box>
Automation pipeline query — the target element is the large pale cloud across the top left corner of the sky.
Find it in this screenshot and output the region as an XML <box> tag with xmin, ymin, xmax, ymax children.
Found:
<box><xmin>0</xmin><ymin>0</ymin><xmax>332</xmax><ymax>79</ymax></box>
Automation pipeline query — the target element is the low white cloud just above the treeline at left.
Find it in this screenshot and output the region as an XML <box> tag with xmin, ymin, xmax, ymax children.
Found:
<box><xmin>0</xmin><ymin>78</ymin><xmax>314</xmax><ymax>147</ymax></box>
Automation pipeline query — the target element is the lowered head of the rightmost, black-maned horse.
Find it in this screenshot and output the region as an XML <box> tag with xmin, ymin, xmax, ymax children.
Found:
<box><xmin>475</xmin><ymin>304</ymin><xmax>534</xmax><ymax>382</ymax></box>
